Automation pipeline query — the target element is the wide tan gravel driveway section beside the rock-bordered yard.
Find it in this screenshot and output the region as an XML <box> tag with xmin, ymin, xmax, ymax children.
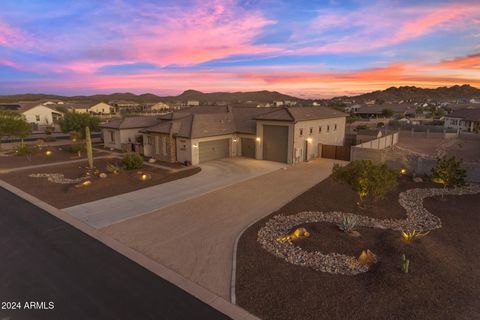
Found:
<box><xmin>101</xmin><ymin>159</ymin><xmax>341</xmax><ymax>299</ymax></box>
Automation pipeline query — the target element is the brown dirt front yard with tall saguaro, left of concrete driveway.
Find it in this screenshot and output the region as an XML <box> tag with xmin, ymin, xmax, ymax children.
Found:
<box><xmin>0</xmin><ymin>157</ymin><xmax>200</xmax><ymax>208</ymax></box>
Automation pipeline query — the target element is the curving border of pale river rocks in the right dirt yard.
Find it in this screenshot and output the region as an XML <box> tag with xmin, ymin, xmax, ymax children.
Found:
<box><xmin>257</xmin><ymin>184</ymin><xmax>480</xmax><ymax>275</ymax></box>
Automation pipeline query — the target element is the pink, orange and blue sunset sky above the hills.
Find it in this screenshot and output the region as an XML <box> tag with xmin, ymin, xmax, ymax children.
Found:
<box><xmin>0</xmin><ymin>0</ymin><xmax>480</xmax><ymax>97</ymax></box>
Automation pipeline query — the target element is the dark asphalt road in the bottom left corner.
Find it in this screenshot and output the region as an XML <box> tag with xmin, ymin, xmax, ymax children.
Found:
<box><xmin>0</xmin><ymin>188</ymin><xmax>231</xmax><ymax>320</ymax></box>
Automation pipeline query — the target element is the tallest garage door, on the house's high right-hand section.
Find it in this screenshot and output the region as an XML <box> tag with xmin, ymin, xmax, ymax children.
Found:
<box><xmin>263</xmin><ymin>126</ymin><xmax>288</xmax><ymax>162</ymax></box>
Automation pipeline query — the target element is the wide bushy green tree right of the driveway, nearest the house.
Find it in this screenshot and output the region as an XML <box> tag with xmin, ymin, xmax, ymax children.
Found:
<box><xmin>333</xmin><ymin>160</ymin><xmax>398</xmax><ymax>204</ymax></box>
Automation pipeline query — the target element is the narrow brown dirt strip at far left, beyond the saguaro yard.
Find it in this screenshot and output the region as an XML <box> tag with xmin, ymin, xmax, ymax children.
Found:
<box><xmin>0</xmin><ymin>145</ymin><xmax>108</xmax><ymax>169</ymax></box>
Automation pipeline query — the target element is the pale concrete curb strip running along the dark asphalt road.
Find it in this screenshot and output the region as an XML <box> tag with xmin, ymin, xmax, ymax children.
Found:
<box><xmin>0</xmin><ymin>180</ymin><xmax>258</xmax><ymax>320</ymax></box>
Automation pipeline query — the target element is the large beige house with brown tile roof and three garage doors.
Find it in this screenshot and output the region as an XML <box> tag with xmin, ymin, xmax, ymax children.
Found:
<box><xmin>102</xmin><ymin>106</ymin><xmax>346</xmax><ymax>165</ymax></box>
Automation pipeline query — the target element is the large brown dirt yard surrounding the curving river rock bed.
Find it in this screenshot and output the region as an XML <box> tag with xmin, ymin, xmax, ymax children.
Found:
<box><xmin>236</xmin><ymin>178</ymin><xmax>480</xmax><ymax>320</ymax></box>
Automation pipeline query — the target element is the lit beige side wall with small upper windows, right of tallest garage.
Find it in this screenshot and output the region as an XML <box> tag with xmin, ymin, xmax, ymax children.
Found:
<box><xmin>292</xmin><ymin>117</ymin><xmax>346</xmax><ymax>163</ymax></box>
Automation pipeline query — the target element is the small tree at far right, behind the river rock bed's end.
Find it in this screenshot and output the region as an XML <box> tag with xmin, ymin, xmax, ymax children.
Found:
<box><xmin>432</xmin><ymin>157</ymin><xmax>467</xmax><ymax>189</ymax></box>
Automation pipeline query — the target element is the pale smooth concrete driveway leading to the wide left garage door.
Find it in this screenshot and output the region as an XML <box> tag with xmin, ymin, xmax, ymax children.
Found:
<box><xmin>63</xmin><ymin>158</ymin><xmax>285</xmax><ymax>228</ymax></box>
